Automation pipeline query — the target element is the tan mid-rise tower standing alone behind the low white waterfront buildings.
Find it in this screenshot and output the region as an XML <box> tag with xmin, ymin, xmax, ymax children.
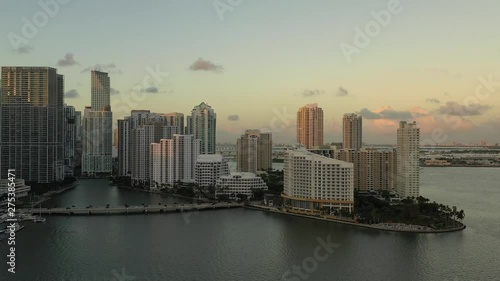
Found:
<box><xmin>237</xmin><ymin>130</ymin><xmax>273</xmax><ymax>173</ymax></box>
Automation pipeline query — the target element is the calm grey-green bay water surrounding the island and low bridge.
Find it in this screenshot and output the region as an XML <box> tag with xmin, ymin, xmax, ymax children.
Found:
<box><xmin>0</xmin><ymin>168</ymin><xmax>500</xmax><ymax>281</ymax></box>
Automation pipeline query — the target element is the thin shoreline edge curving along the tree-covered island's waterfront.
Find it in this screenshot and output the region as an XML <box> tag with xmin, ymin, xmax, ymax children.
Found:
<box><xmin>243</xmin><ymin>205</ymin><xmax>466</xmax><ymax>234</ymax></box>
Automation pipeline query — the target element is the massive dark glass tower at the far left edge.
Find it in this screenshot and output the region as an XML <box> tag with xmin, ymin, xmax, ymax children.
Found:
<box><xmin>0</xmin><ymin>67</ymin><xmax>64</xmax><ymax>183</ymax></box>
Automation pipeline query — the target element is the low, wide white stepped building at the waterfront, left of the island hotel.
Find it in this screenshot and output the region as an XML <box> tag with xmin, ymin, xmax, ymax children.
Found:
<box><xmin>215</xmin><ymin>172</ymin><xmax>267</xmax><ymax>198</ymax></box>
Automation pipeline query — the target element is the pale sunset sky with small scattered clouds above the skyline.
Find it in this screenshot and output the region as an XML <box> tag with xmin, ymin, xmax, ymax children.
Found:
<box><xmin>0</xmin><ymin>0</ymin><xmax>500</xmax><ymax>144</ymax></box>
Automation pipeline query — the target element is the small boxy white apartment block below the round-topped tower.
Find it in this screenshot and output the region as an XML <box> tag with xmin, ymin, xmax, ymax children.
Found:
<box><xmin>195</xmin><ymin>154</ymin><xmax>229</xmax><ymax>187</ymax></box>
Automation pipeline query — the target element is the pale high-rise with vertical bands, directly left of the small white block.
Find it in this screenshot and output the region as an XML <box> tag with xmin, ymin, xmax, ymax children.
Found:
<box><xmin>149</xmin><ymin>134</ymin><xmax>201</xmax><ymax>189</ymax></box>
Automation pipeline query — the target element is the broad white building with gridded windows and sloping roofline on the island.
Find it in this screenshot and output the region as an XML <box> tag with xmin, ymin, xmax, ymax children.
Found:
<box><xmin>282</xmin><ymin>148</ymin><xmax>354</xmax><ymax>213</ymax></box>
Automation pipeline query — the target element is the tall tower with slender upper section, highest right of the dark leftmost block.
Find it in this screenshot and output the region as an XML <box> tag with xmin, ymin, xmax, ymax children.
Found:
<box><xmin>82</xmin><ymin>71</ymin><xmax>113</xmax><ymax>176</ymax></box>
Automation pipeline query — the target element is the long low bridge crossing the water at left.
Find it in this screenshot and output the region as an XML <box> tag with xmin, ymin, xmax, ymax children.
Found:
<box><xmin>19</xmin><ymin>203</ymin><xmax>243</xmax><ymax>215</ymax></box>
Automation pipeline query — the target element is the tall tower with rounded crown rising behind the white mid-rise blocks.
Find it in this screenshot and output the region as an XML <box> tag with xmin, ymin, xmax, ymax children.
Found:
<box><xmin>186</xmin><ymin>102</ymin><xmax>217</xmax><ymax>154</ymax></box>
